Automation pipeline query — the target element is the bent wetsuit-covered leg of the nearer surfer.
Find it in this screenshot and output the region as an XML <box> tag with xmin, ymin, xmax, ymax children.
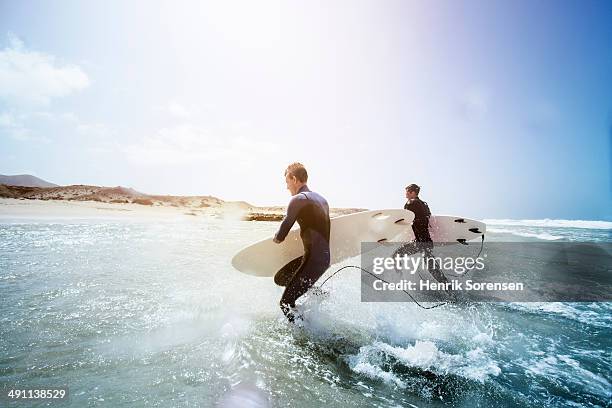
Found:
<box><xmin>280</xmin><ymin>253</ymin><xmax>329</xmax><ymax>322</ymax></box>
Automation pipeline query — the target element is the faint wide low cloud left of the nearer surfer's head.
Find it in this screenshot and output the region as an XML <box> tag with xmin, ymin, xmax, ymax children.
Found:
<box><xmin>122</xmin><ymin>124</ymin><xmax>278</xmax><ymax>166</ymax></box>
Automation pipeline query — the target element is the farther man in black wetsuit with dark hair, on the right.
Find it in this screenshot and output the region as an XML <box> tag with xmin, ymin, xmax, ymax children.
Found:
<box><xmin>393</xmin><ymin>184</ymin><xmax>448</xmax><ymax>283</ymax></box>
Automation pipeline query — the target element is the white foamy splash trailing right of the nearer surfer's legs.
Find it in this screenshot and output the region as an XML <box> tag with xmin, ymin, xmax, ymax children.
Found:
<box><xmin>300</xmin><ymin>274</ymin><xmax>501</xmax><ymax>388</ymax></box>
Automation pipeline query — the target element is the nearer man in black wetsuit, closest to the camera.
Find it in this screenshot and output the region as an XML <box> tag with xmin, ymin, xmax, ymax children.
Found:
<box><xmin>274</xmin><ymin>163</ymin><xmax>330</xmax><ymax>322</ymax></box>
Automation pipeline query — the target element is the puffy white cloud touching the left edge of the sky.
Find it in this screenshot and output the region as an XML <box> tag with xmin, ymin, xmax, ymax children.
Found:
<box><xmin>0</xmin><ymin>34</ymin><xmax>89</xmax><ymax>106</ymax></box>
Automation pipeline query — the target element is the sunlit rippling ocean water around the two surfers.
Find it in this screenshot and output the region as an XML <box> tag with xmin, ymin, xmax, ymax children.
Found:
<box><xmin>0</xmin><ymin>217</ymin><xmax>612</xmax><ymax>407</ymax></box>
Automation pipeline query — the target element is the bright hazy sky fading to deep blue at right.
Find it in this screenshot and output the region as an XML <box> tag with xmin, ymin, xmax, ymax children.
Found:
<box><xmin>0</xmin><ymin>0</ymin><xmax>612</xmax><ymax>220</ymax></box>
